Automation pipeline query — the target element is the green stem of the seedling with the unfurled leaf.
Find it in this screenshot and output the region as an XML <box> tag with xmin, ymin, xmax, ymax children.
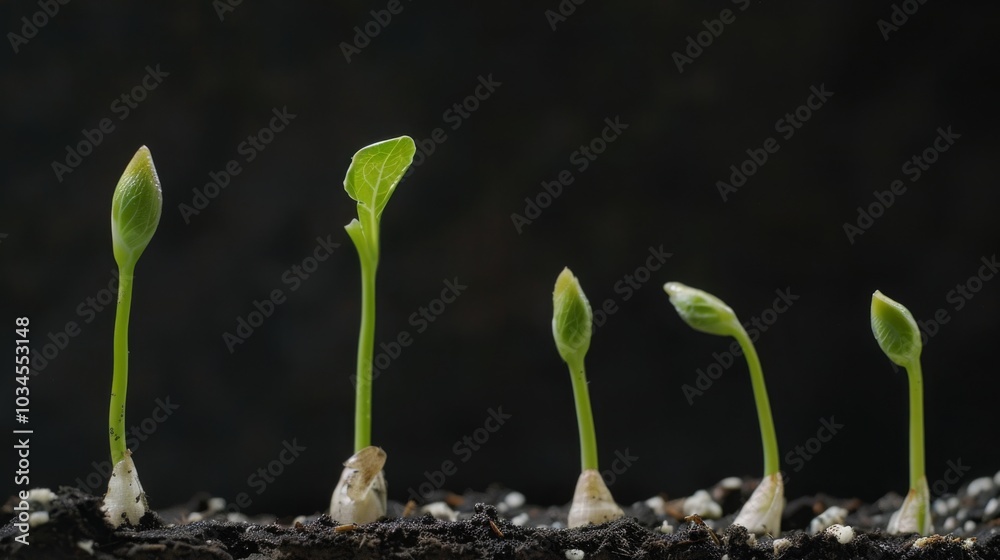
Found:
<box><xmin>354</xmin><ymin>251</ymin><xmax>378</xmax><ymax>453</ymax></box>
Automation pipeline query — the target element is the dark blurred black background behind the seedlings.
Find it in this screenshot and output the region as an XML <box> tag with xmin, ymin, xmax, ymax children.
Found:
<box><xmin>0</xmin><ymin>0</ymin><xmax>1000</xmax><ymax>515</ymax></box>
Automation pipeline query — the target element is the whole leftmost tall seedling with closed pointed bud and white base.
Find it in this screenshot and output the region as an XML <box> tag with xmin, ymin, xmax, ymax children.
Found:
<box><xmin>102</xmin><ymin>146</ymin><xmax>163</xmax><ymax>527</ymax></box>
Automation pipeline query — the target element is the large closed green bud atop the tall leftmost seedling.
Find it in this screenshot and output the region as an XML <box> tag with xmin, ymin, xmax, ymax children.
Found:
<box><xmin>111</xmin><ymin>146</ymin><xmax>163</xmax><ymax>266</ymax></box>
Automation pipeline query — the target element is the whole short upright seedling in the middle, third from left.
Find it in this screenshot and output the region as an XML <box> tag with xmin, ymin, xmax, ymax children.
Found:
<box><xmin>552</xmin><ymin>268</ymin><xmax>625</xmax><ymax>527</ymax></box>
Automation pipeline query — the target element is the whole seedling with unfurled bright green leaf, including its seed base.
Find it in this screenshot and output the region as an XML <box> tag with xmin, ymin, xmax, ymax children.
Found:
<box><xmin>330</xmin><ymin>136</ymin><xmax>416</xmax><ymax>523</ymax></box>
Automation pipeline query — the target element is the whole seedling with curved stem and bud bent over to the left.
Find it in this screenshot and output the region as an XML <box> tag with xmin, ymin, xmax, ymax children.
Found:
<box><xmin>663</xmin><ymin>282</ymin><xmax>785</xmax><ymax>535</ymax></box>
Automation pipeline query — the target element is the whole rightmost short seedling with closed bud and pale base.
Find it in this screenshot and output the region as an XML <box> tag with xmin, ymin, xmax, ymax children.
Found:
<box><xmin>871</xmin><ymin>290</ymin><xmax>934</xmax><ymax>535</ymax></box>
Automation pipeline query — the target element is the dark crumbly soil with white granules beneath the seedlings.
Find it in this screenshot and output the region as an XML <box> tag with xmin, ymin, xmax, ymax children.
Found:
<box><xmin>0</xmin><ymin>479</ymin><xmax>1000</xmax><ymax>560</ymax></box>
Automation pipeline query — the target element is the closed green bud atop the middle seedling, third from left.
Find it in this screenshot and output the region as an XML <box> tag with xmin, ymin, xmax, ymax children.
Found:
<box><xmin>552</xmin><ymin>268</ymin><xmax>594</xmax><ymax>363</ymax></box>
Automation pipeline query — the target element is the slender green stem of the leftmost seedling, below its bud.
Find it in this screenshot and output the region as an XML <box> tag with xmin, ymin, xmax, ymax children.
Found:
<box><xmin>108</xmin><ymin>263</ymin><xmax>135</xmax><ymax>465</ymax></box>
